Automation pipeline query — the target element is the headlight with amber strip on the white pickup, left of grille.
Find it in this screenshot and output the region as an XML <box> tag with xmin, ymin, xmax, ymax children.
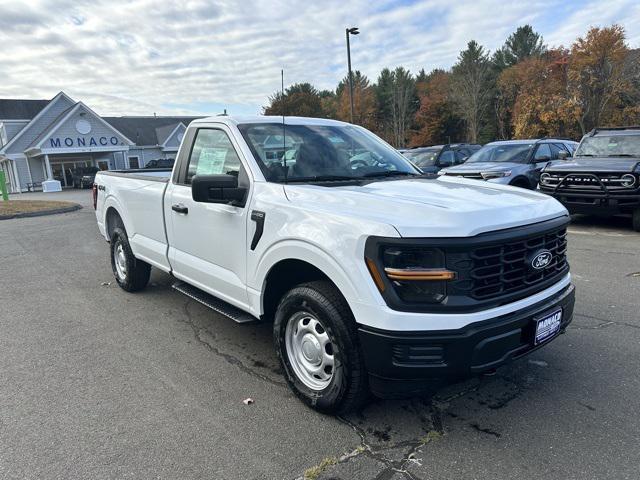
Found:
<box><xmin>366</xmin><ymin>245</ymin><xmax>455</xmax><ymax>304</ymax></box>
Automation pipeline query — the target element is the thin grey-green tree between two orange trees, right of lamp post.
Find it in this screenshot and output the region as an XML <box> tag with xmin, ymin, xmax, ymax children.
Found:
<box><xmin>376</xmin><ymin>67</ymin><xmax>418</xmax><ymax>147</ymax></box>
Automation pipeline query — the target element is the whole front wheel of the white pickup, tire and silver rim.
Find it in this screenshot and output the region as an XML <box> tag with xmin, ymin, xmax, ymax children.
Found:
<box><xmin>273</xmin><ymin>281</ymin><xmax>369</xmax><ymax>413</ymax></box>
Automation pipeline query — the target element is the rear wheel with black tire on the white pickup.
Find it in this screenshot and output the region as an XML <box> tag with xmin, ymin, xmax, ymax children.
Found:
<box><xmin>111</xmin><ymin>227</ymin><xmax>151</xmax><ymax>292</ymax></box>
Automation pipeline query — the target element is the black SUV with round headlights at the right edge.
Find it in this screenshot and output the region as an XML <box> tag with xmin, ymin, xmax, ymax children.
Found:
<box><xmin>540</xmin><ymin>127</ymin><xmax>640</xmax><ymax>231</ymax></box>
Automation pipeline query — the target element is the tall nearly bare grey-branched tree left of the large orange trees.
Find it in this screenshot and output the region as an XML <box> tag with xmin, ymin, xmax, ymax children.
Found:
<box><xmin>451</xmin><ymin>40</ymin><xmax>494</xmax><ymax>143</ymax></box>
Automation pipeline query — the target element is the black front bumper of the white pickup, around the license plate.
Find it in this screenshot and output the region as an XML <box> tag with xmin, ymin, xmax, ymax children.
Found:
<box><xmin>358</xmin><ymin>285</ymin><xmax>575</xmax><ymax>398</ymax></box>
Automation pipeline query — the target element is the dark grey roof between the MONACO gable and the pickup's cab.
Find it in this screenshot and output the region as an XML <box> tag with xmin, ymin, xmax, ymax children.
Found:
<box><xmin>102</xmin><ymin>117</ymin><xmax>200</xmax><ymax>146</ymax></box>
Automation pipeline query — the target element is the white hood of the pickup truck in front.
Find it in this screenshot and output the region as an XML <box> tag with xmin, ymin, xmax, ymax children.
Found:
<box><xmin>285</xmin><ymin>176</ymin><xmax>567</xmax><ymax>237</ymax></box>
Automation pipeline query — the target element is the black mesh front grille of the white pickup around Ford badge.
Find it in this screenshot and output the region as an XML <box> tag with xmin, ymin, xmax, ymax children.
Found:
<box><xmin>470</xmin><ymin>228</ymin><xmax>567</xmax><ymax>300</ymax></box>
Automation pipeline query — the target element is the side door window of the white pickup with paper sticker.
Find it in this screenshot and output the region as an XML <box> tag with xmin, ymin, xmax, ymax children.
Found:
<box><xmin>185</xmin><ymin>128</ymin><xmax>242</xmax><ymax>185</ymax></box>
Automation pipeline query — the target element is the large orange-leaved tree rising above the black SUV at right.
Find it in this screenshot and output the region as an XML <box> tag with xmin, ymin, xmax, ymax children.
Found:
<box><xmin>568</xmin><ymin>25</ymin><xmax>633</xmax><ymax>134</ymax></box>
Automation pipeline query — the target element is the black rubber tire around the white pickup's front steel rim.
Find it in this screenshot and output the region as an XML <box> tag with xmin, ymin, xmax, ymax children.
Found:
<box><xmin>273</xmin><ymin>281</ymin><xmax>370</xmax><ymax>413</ymax></box>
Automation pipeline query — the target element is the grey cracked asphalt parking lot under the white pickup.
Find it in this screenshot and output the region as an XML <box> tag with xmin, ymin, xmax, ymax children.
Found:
<box><xmin>0</xmin><ymin>191</ymin><xmax>640</xmax><ymax>480</ymax></box>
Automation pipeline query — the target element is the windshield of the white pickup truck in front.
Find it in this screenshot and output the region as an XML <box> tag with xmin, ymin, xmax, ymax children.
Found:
<box><xmin>238</xmin><ymin>123</ymin><xmax>420</xmax><ymax>182</ymax></box>
